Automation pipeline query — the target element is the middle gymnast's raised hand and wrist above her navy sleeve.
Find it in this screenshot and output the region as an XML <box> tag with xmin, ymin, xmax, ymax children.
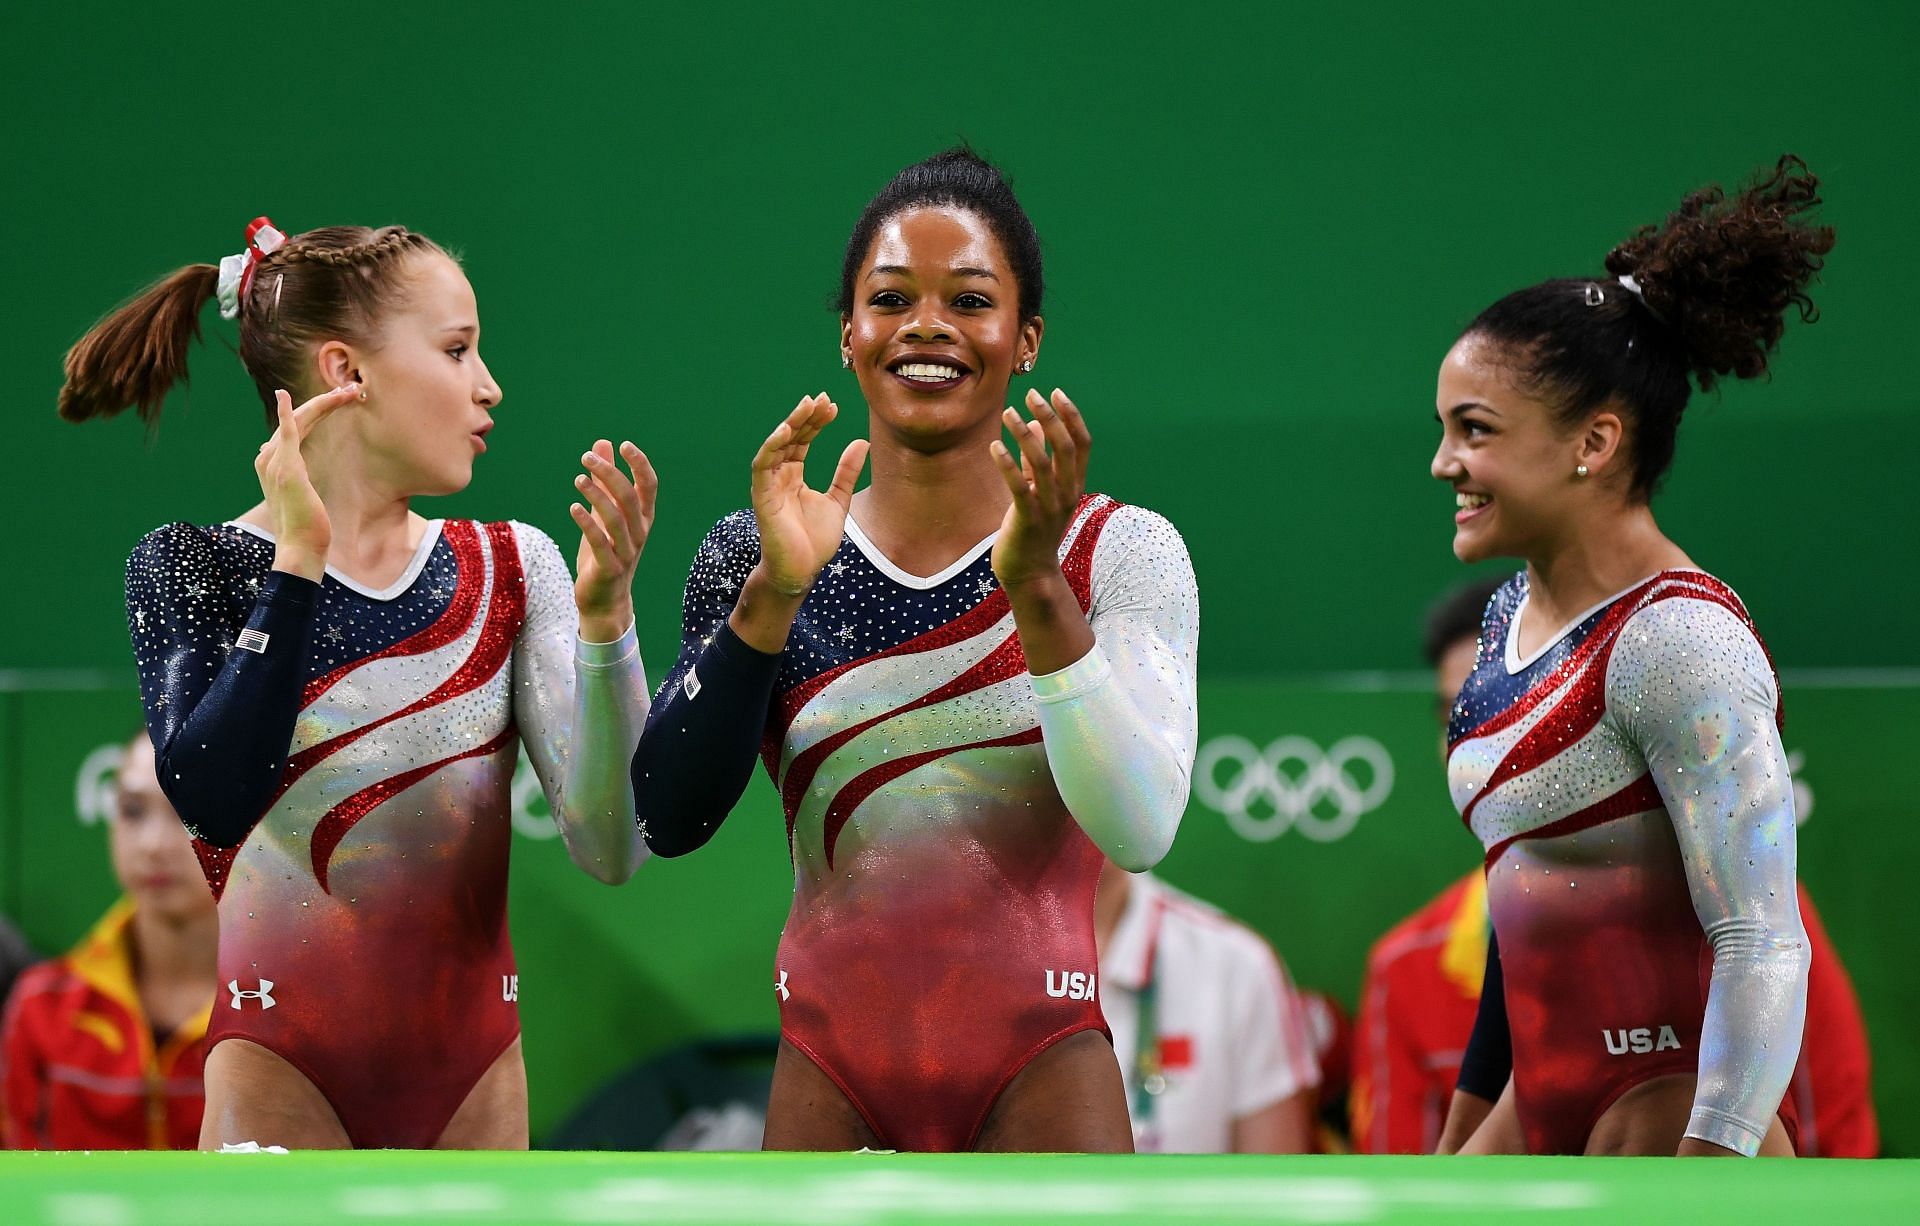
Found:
<box><xmin>728</xmin><ymin>391</ymin><xmax>866</xmax><ymax>652</ymax></box>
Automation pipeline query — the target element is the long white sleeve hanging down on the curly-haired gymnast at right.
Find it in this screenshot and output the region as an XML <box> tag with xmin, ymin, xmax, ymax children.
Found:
<box><xmin>1607</xmin><ymin>597</ymin><xmax>1811</xmax><ymax>1155</ymax></box>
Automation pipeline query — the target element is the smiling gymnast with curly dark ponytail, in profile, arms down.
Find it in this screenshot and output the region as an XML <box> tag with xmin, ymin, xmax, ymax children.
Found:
<box><xmin>1432</xmin><ymin>157</ymin><xmax>1834</xmax><ymax>1157</ymax></box>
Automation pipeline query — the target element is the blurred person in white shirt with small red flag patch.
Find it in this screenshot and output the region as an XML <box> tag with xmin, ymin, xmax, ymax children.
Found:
<box><xmin>1094</xmin><ymin>861</ymin><xmax>1321</xmax><ymax>1153</ymax></box>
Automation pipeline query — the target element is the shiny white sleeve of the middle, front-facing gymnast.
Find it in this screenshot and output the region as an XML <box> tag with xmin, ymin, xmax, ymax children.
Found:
<box><xmin>1033</xmin><ymin>507</ymin><xmax>1200</xmax><ymax>873</ymax></box>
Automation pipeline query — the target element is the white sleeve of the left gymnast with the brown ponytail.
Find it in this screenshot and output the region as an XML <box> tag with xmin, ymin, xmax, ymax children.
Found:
<box><xmin>513</xmin><ymin>522</ymin><xmax>649</xmax><ymax>884</ymax></box>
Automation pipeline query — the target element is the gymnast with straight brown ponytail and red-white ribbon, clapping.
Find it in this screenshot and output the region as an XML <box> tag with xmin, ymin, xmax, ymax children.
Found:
<box><xmin>60</xmin><ymin>219</ymin><xmax>655</xmax><ymax>1149</ymax></box>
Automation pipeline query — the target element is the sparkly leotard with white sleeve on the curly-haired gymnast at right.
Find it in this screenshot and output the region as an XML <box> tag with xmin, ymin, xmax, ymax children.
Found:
<box><xmin>1448</xmin><ymin>570</ymin><xmax>1809</xmax><ymax>1155</ymax></box>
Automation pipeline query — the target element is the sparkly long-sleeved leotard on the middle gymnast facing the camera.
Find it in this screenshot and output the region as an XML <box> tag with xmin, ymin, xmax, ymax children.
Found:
<box><xmin>634</xmin><ymin>495</ymin><xmax>1198</xmax><ymax>1151</ymax></box>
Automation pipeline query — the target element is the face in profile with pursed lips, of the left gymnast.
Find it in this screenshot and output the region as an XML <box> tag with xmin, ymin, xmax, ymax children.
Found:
<box><xmin>332</xmin><ymin>253</ymin><xmax>501</xmax><ymax>495</ymax></box>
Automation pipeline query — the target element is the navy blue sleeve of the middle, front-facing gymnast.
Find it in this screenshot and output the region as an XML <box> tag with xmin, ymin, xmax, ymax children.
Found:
<box><xmin>634</xmin><ymin>510</ymin><xmax>780</xmax><ymax>856</ymax></box>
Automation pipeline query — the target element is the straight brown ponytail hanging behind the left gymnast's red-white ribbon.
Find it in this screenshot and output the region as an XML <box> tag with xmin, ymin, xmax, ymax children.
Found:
<box><xmin>60</xmin><ymin>265</ymin><xmax>221</xmax><ymax>426</ymax></box>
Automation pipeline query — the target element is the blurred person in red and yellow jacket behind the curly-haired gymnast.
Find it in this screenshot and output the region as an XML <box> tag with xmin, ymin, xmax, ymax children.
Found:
<box><xmin>1350</xmin><ymin>578</ymin><xmax>1880</xmax><ymax>1157</ymax></box>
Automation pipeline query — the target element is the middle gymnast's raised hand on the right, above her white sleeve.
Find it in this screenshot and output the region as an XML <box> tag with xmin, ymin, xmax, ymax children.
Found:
<box><xmin>993</xmin><ymin>388</ymin><xmax>1092</xmax><ymax>595</ymax></box>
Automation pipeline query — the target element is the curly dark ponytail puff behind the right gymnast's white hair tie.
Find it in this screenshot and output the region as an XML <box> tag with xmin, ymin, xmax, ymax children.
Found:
<box><xmin>1607</xmin><ymin>153</ymin><xmax>1834</xmax><ymax>391</ymax></box>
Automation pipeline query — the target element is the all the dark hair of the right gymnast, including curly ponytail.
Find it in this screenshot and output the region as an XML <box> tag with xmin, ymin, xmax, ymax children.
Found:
<box><xmin>1463</xmin><ymin>153</ymin><xmax>1834</xmax><ymax>499</ymax></box>
